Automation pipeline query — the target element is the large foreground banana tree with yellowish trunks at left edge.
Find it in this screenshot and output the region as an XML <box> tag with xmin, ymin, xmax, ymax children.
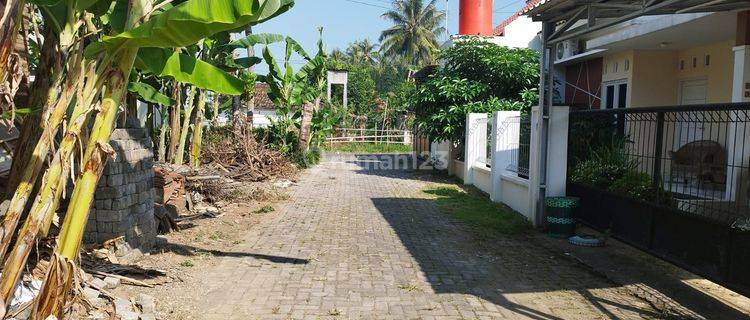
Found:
<box><xmin>0</xmin><ymin>0</ymin><xmax>293</xmax><ymax>319</ymax></box>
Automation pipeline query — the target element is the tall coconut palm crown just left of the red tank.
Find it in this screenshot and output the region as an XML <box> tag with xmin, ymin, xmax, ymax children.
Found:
<box><xmin>380</xmin><ymin>0</ymin><xmax>445</xmax><ymax>65</ymax></box>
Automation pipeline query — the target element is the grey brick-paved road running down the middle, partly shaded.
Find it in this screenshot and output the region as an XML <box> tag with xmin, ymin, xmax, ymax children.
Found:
<box><xmin>196</xmin><ymin>154</ymin><xmax>656</xmax><ymax>320</ymax></box>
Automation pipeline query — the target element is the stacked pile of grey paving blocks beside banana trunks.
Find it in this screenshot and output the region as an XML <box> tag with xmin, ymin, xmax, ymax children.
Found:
<box><xmin>84</xmin><ymin>129</ymin><xmax>156</xmax><ymax>252</ymax></box>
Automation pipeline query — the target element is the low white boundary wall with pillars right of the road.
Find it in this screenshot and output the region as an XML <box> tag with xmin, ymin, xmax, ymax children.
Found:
<box><xmin>456</xmin><ymin>107</ymin><xmax>569</xmax><ymax>228</ymax></box>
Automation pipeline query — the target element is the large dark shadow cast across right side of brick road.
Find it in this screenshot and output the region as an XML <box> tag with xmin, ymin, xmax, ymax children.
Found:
<box><xmin>372</xmin><ymin>198</ymin><xmax>661</xmax><ymax>319</ymax></box>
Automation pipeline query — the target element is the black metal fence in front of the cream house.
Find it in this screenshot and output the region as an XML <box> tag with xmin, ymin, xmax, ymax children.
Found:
<box><xmin>568</xmin><ymin>104</ymin><xmax>750</xmax><ymax>294</ymax></box>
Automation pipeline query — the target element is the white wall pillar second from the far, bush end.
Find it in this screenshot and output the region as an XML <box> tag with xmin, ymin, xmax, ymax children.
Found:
<box><xmin>490</xmin><ymin>111</ymin><xmax>521</xmax><ymax>202</ymax></box>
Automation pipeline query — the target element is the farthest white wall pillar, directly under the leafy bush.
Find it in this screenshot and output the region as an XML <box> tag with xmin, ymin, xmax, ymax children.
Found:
<box><xmin>464</xmin><ymin>113</ymin><xmax>487</xmax><ymax>184</ymax></box>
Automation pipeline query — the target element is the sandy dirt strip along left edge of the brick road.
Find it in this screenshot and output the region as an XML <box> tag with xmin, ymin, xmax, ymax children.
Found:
<box><xmin>108</xmin><ymin>181</ymin><xmax>288</xmax><ymax>320</ymax></box>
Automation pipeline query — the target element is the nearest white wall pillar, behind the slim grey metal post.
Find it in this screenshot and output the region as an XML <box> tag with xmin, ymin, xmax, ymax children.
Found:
<box><xmin>529</xmin><ymin>106</ymin><xmax>570</xmax><ymax>226</ymax></box>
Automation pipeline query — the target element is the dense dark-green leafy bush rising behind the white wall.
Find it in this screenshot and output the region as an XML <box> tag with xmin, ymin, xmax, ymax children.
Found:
<box><xmin>412</xmin><ymin>39</ymin><xmax>539</xmax><ymax>141</ymax></box>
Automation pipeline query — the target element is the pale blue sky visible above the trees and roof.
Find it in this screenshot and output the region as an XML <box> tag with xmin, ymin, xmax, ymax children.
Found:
<box><xmin>253</xmin><ymin>0</ymin><xmax>525</xmax><ymax>73</ymax></box>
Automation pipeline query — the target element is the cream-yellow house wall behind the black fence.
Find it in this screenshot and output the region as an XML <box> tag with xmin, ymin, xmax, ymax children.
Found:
<box><xmin>602</xmin><ymin>40</ymin><xmax>734</xmax><ymax>190</ymax></box>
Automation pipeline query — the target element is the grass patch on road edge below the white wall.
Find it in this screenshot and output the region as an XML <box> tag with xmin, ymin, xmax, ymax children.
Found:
<box><xmin>424</xmin><ymin>187</ymin><xmax>531</xmax><ymax>234</ymax></box>
